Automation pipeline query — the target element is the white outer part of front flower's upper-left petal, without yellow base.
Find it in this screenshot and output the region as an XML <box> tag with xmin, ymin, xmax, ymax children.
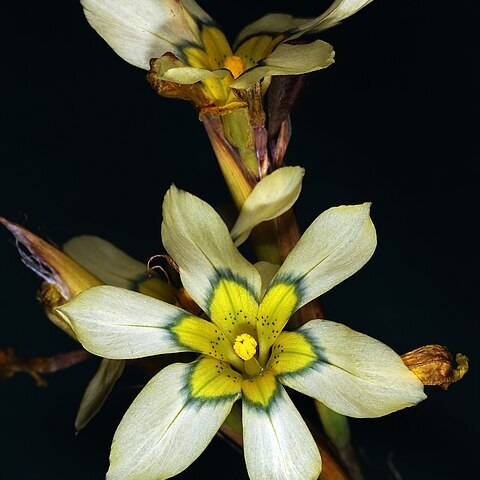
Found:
<box><xmin>162</xmin><ymin>186</ymin><xmax>261</xmax><ymax>314</ymax></box>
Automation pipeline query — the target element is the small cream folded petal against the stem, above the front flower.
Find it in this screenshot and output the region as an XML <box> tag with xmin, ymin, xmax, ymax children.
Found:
<box><xmin>230</xmin><ymin>167</ymin><xmax>305</xmax><ymax>246</ymax></box>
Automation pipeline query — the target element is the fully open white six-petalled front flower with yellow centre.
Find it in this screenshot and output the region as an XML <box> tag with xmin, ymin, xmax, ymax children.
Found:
<box><xmin>57</xmin><ymin>187</ymin><xmax>425</xmax><ymax>480</ymax></box>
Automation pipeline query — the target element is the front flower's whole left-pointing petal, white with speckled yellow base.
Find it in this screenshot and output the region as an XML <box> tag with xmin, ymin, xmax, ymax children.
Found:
<box><xmin>55</xmin><ymin>286</ymin><xmax>241</xmax><ymax>367</ymax></box>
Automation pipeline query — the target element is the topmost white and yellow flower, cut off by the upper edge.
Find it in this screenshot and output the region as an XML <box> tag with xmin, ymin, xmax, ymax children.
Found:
<box><xmin>82</xmin><ymin>0</ymin><xmax>371</xmax><ymax>109</ymax></box>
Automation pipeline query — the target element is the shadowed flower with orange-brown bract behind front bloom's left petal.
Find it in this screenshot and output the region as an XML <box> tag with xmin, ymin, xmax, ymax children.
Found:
<box><xmin>0</xmin><ymin>217</ymin><xmax>175</xmax><ymax>431</ymax></box>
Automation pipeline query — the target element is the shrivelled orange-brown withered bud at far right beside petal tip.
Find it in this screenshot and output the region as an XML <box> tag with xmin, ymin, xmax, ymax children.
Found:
<box><xmin>402</xmin><ymin>345</ymin><xmax>468</xmax><ymax>390</ymax></box>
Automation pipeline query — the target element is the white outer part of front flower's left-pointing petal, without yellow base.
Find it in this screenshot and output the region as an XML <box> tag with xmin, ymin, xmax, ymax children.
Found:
<box><xmin>55</xmin><ymin>286</ymin><xmax>195</xmax><ymax>359</ymax></box>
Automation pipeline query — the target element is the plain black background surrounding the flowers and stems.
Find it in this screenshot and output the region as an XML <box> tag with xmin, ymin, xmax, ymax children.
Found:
<box><xmin>0</xmin><ymin>0</ymin><xmax>480</xmax><ymax>480</ymax></box>
